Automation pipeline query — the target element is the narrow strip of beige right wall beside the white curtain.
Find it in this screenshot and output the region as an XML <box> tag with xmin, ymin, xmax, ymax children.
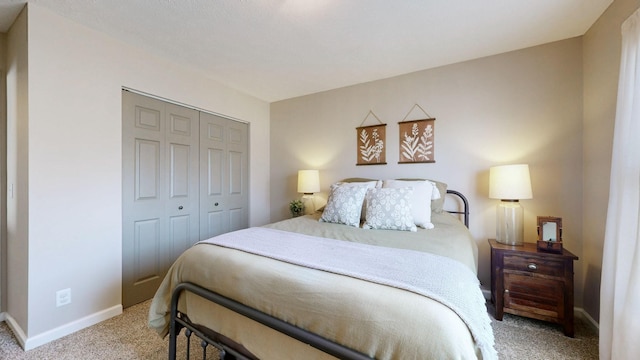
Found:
<box><xmin>579</xmin><ymin>0</ymin><xmax>640</xmax><ymax>320</ymax></box>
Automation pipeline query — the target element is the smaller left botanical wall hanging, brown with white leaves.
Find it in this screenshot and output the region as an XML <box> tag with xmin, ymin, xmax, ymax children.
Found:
<box><xmin>356</xmin><ymin>110</ymin><xmax>387</xmax><ymax>165</ymax></box>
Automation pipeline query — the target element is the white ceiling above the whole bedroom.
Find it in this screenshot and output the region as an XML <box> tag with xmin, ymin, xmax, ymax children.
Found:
<box><xmin>0</xmin><ymin>0</ymin><xmax>613</xmax><ymax>102</ymax></box>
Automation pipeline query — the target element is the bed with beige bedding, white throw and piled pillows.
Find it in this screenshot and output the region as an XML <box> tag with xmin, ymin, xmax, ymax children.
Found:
<box><xmin>149</xmin><ymin>179</ymin><xmax>497</xmax><ymax>359</ymax></box>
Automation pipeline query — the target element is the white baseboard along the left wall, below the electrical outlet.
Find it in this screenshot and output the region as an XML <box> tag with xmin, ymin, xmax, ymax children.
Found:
<box><xmin>6</xmin><ymin>305</ymin><xmax>122</xmax><ymax>351</ymax></box>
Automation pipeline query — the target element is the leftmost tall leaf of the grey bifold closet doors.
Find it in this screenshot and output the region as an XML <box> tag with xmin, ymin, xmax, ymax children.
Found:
<box><xmin>122</xmin><ymin>92</ymin><xmax>166</xmax><ymax>306</ymax></box>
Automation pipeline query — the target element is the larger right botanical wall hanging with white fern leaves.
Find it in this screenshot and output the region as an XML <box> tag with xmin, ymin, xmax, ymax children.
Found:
<box><xmin>398</xmin><ymin>104</ymin><xmax>436</xmax><ymax>164</ymax></box>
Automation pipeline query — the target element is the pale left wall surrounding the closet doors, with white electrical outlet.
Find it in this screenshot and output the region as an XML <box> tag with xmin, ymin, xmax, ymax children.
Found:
<box><xmin>2</xmin><ymin>3</ymin><xmax>269</xmax><ymax>348</ymax></box>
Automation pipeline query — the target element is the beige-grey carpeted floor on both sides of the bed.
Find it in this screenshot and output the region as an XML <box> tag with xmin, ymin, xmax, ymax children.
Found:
<box><xmin>0</xmin><ymin>301</ymin><xmax>598</xmax><ymax>360</ymax></box>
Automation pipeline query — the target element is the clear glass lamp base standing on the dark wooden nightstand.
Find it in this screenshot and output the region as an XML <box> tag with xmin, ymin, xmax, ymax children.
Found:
<box><xmin>496</xmin><ymin>200</ymin><xmax>524</xmax><ymax>245</ymax></box>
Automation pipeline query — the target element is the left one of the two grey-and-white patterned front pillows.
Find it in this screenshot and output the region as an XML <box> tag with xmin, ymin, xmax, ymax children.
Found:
<box><xmin>320</xmin><ymin>184</ymin><xmax>368</xmax><ymax>227</ymax></box>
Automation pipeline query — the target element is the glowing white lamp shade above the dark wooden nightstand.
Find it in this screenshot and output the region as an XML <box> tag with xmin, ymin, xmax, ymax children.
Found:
<box><xmin>489</xmin><ymin>164</ymin><xmax>533</xmax><ymax>200</ymax></box>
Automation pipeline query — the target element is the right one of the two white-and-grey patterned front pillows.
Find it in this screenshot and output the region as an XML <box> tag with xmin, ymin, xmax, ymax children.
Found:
<box><xmin>362</xmin><ymin>187</ymin><xmax>417</xmax><ymax>232</ymax></box>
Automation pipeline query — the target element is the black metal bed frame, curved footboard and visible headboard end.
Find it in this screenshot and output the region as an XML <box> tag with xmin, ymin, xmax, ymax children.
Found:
<box><xmin>169</xmin><ymin>190</ymin><xmax>469</xmax><ymax>360</ymax></box>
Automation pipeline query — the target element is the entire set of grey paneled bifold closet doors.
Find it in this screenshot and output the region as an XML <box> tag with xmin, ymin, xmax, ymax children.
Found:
<box><xmin>122</xmin><ymin>90</ymin><xmax>249</xmax><ymax>307</ymax></box>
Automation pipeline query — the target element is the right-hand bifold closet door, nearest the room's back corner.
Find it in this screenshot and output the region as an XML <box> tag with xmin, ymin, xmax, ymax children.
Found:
<box><xmin>200</xmin><ymin>113</ymin><xmax>249</xmax><ymax>239</ymax></box>
